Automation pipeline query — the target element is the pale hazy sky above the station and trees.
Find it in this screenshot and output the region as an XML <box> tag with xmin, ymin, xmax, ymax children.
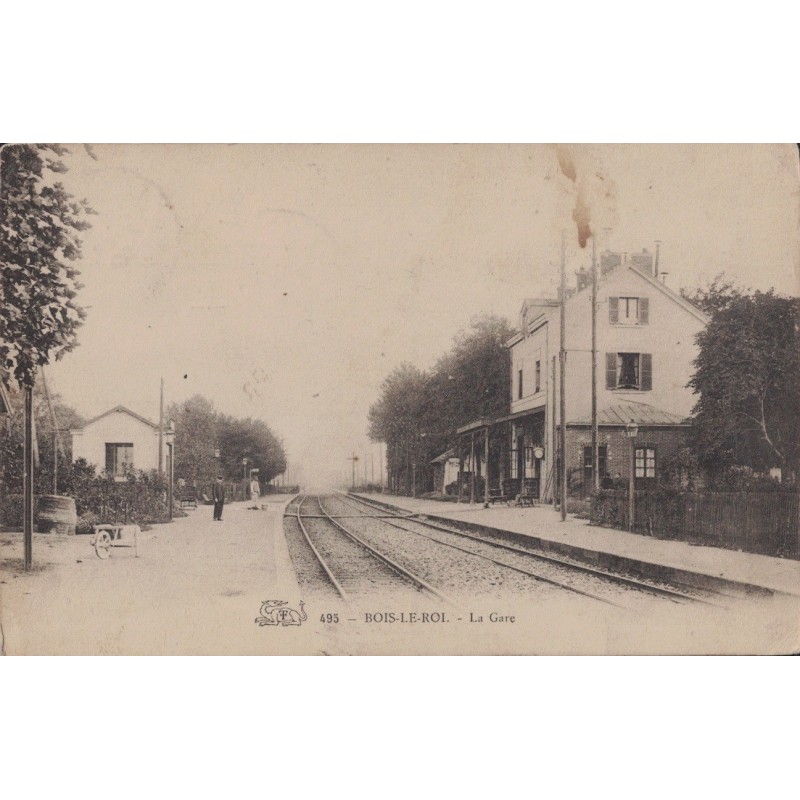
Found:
<box><xmin>49</xmin><ymin>145</ymin><xmax>800</xmax><ymax>488</ymax></box>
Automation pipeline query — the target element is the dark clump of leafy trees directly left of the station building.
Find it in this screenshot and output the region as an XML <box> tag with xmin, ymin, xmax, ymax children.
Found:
<box><xmin>369</xmin><ymin>315</ymin><xmax>513</xmax><ymax>493</ymax></box>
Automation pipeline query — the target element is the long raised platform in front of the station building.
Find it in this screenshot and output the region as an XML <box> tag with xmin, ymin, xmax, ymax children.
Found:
<box><xmin>360</xmin><ymin>494</ymin><xmax>800</xmax><ymax>597</ymax></box>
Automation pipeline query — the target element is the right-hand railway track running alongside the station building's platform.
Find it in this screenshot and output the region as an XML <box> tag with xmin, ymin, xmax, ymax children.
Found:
<box><xmin>342</xmin><ymin>494</ymin><xmax>716</xmax><ymax>605</ymax></box>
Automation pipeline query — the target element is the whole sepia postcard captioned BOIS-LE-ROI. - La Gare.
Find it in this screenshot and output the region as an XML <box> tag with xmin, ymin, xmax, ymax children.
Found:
<box><xmin>0</xmin><ymin>144</ymin><xmax>800</xmax><ymax>655</ymax></box>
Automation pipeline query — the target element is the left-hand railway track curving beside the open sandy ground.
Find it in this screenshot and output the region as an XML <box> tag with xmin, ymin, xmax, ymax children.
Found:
<box><xmin>294</xmin><ymin>495</ymin><xmax>449</xmax><ymax>602</ymax></box>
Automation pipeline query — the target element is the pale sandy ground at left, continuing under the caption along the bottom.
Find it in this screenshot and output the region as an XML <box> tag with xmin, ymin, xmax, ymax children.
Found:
<box><xmin>0</xmin><ymin>498</ymin><xmax>800</xmax><ymax>655</ymax></box>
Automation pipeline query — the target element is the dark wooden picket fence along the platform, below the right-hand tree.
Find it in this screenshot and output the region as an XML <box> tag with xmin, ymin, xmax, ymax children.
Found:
<box><xmin>592</xmin><ymin>490</ymin><xmax>800</xmax><ymax>558</ymax></box>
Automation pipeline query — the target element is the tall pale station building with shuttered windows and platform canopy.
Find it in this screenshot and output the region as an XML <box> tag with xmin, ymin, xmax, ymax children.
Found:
<box><xmin>457</xmin><ymin>250</ymin><xmax>708</xmax><ymax>501</ymax></box>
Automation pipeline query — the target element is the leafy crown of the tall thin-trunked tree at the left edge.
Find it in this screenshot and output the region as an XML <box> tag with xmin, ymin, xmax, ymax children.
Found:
<box><xmin>0</xmin><ymin>145</ymin><xmax>94</xmax><ymax>386</ymax></box>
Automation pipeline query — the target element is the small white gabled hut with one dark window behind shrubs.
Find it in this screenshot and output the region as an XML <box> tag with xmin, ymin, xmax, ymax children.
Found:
<box><xmin>70</xmin><ymin>406</ymin><xmax>166</xmax><ymax>480</ymax></box>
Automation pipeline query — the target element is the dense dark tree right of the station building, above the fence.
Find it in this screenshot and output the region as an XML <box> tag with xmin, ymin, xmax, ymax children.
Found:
<box><xmin>689</xmin><ymin>290</ymin><xmax>800</xmax><ymax>480</ymax></box>
